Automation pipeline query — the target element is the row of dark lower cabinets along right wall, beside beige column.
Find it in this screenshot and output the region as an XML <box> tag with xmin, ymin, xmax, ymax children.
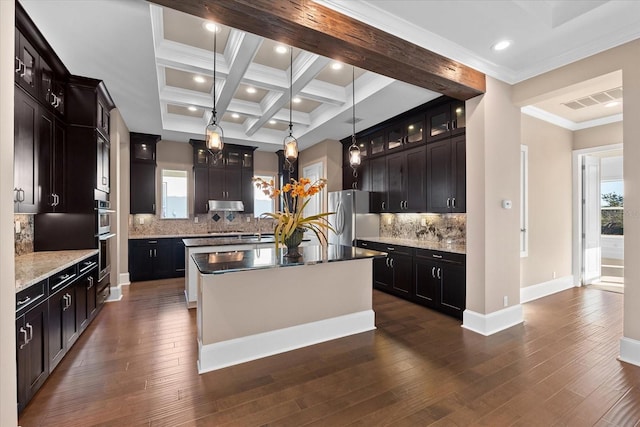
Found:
<box><xmin>357</xmin><ymin>241</ymin><xmax>466</xmax><ymax>319</ymax></box>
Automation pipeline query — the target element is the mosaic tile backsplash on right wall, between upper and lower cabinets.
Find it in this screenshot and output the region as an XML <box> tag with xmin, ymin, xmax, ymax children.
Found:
<box><xmin>380</xmin><ymin>214</ymin><xmax>467</xmax><ymax>244</ymax></box>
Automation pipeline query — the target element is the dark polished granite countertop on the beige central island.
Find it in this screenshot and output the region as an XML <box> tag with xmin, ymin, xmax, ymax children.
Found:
<box><xmin>191</xmin><ymin>245</ymin><xmax>386</xmax><ymax>274</ymax></box>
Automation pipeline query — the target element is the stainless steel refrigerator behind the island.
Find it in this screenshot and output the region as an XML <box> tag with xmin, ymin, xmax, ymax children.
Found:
<box><xmin>329</xmin><ymin>190</ymin><xmax>380</xmax><ymax>246</ymax></box>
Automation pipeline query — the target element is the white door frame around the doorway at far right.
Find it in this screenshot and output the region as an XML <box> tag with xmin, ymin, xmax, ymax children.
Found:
<box><xmin>572</xmin><ymin>144</ymin><xmax>623</xmax><ymax>286</ymax></box>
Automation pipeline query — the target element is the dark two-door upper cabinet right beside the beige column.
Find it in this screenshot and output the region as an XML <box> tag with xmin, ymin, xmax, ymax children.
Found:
<box><xmin>427</xmin><ymin>135</ymin><xmax>466</xmax><ymax>213</ymax></box>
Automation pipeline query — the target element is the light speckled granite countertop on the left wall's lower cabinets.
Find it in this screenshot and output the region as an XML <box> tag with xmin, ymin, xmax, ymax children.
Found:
<box><xmin>15</xmin><ymin>249</ymin><xmax>98</xmax><ymax>293</ymax></box>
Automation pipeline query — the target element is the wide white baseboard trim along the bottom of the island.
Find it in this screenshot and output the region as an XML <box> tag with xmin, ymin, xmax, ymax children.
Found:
<box><xmin>198</xmin><ymin>310</ymin><xmax>376</xmax><ymax>374</ymax></box>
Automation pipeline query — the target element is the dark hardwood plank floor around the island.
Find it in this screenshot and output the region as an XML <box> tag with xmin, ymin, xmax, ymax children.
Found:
<box><xmin>20</xmin><ymin>280</ymin><xmax>640</xmax><ymax>427</ymax></box>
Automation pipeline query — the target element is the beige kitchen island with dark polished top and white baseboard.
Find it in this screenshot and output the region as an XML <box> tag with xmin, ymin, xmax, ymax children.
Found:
<box><xmin>192</xmin><ymin>245</ymin><xmax>386</xmax><ymax>373</ymax></box>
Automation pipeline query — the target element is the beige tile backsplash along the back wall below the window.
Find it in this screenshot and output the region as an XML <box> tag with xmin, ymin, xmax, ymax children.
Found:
<box><xmin>129</xmin><ymin>212</ymin><xmax>274</xmax><ymax>236</ymax></box>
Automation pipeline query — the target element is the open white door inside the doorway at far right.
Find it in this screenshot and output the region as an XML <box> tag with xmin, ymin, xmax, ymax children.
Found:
<box><xmin>582</xmin><ymin>156</ymin><xmax>601</xmax><ymax>285</ymax></box>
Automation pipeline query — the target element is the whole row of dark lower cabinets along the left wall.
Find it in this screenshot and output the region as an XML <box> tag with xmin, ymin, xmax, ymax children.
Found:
<box><xmin>16</xmin><ymin>255</ymin><xmax>101</xmax><ymax>412</ymax></box>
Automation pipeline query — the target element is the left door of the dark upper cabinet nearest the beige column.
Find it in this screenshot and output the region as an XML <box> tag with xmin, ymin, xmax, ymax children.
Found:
<box><xmin>427</xmin><ymin>139</ymin><xmax>451</xmax><ymax>213</ymax></box>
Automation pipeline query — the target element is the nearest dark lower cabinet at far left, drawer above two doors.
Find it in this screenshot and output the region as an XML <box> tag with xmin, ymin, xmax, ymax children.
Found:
<box><xmin>16</xmin><ymin>280</ymin><xmax>49</xmax><ymax>411</ymax></box>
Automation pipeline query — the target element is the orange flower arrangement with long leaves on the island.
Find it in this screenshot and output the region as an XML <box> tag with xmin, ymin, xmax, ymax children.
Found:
<box><xmin>253</xmin><ymin>177</ymin><xmax>333</xmax><ymax>249</ymax></box>
